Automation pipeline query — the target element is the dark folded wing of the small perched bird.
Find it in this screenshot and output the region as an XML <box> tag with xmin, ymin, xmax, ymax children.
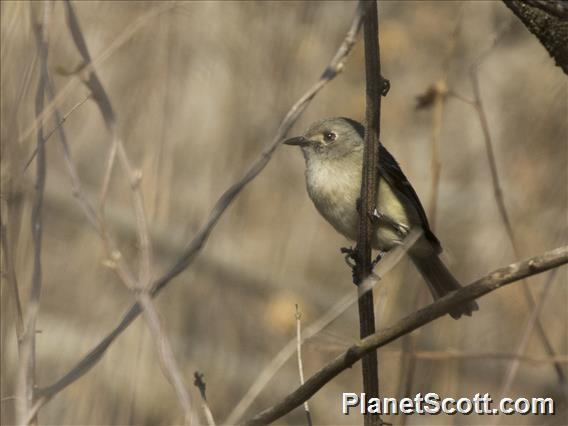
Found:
<box><xmin>379</xmin><ymin>144</ymin><xmax>442</xmax><ymax>251</ymax></box>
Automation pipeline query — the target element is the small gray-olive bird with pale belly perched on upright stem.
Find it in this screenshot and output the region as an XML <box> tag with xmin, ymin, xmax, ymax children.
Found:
<box><xmin>284</xmin><ymin>117</ymin><xmax>479</xmax><ymax>319</ymax></box>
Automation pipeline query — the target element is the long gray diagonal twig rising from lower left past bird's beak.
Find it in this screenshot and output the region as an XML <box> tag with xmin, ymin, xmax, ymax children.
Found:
<box><xmin>39</xmin><ymin>1</ymin><xmax>363</xmax><ymax>412</ymax></box>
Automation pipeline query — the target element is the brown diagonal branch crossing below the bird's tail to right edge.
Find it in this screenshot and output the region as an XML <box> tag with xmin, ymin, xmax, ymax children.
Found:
<box><xmin>245</xmin><ymin>246</ymin><xmax>568</xmax><ymax>425</ymax></box>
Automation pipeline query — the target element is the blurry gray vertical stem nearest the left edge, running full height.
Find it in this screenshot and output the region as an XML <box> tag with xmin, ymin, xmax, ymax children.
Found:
<box><xmin>17</xmin><ymin>1</ymin><xmax>50</xmax><ymax>424</ymax></box>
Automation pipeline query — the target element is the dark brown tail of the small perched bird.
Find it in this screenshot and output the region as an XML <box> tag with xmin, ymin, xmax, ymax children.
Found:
<box><xmin>410</xmin><ymin>251</ymin><xmax>479</xmax><ymax>319</ymax></box>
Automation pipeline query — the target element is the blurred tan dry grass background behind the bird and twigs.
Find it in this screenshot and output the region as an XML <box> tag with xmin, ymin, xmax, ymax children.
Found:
<box><xmin>0</xmin><ymin>1</ymin><xmax>568</xmax><ymax>425</ymax></box>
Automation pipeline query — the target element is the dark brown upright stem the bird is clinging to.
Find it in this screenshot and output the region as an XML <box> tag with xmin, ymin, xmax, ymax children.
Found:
<box><xmin>354</xmin><ymin>0</ymin><xmax>383</xmax><ymax>425</ymax></box>
